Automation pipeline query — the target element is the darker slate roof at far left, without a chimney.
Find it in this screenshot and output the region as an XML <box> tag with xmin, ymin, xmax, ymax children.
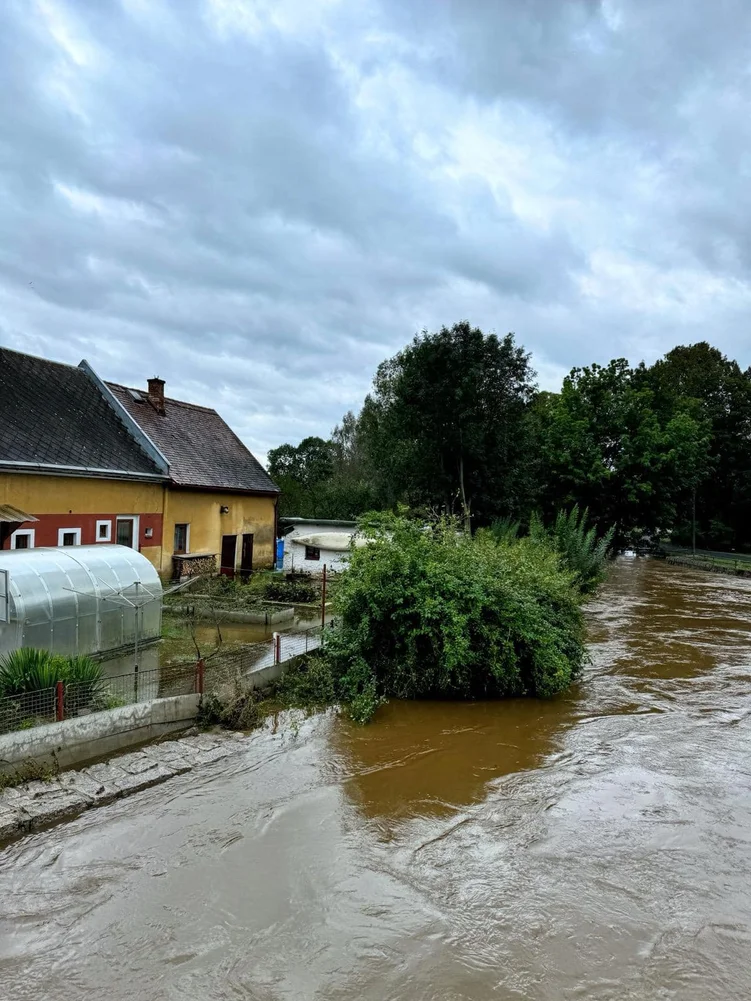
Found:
<box><xmin>0</xmin><ymin>347</ymin><xmax>164</xmax><ymax>474</ymax></box>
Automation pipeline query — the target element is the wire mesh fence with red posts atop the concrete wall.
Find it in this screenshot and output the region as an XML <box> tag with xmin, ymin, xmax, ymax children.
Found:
<box><xmin>0</xmin><ymin>626</ymin><xmax>324</xmax><ymax>734</ymax></box>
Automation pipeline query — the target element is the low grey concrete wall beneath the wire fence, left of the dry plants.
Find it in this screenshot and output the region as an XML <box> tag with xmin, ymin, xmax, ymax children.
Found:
<box><xmin>0</xmin><ymin>696</ymin><xmax>201</xmax><ymax>772</ymax></box>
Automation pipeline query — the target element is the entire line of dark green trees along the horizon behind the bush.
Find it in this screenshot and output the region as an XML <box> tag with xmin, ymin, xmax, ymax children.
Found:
<box><xmin>269</xmin><ymin>322</ymin><xmax>751</xmax><ymax>550</ymax></box>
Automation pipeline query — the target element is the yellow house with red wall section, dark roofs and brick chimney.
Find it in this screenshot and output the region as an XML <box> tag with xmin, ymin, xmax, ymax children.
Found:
<box><xmin>0</xmin><ymin>348</ymin><xmax>279</xmax><ymax>576</ymax></box>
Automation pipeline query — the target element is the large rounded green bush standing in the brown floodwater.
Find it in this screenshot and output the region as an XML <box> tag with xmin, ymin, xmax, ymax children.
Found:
<box><xmin>325</xmin><ymin>520</ymin><xmax>585</xmax><ymax>719</ymax></box>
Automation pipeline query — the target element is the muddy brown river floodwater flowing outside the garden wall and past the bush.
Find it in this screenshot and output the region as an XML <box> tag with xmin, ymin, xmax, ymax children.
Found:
<box><xmin>0</xmin><ymin>559</ymin><xmax>751</xmax><ymax>1001</ymax></box>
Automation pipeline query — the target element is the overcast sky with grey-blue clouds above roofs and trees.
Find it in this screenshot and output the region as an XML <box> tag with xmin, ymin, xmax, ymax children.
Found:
<box><xmin>0</xmin><ymin>0</ymin><xmax>751</xmax><ymax>457</ymax></box>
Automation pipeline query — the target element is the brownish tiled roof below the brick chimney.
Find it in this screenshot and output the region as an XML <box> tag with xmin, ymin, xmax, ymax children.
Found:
<box><xmin>107</xmin><ymin>382</ymin><xmax>278</xmax><ymax>493</ymax></box>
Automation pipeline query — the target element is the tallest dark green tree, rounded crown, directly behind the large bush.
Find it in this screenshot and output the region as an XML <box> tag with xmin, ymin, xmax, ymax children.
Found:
<box><xmin>360</xmin><ymin>322</ymin><xmax>535</xmax><ymax>525</ymax></box>
